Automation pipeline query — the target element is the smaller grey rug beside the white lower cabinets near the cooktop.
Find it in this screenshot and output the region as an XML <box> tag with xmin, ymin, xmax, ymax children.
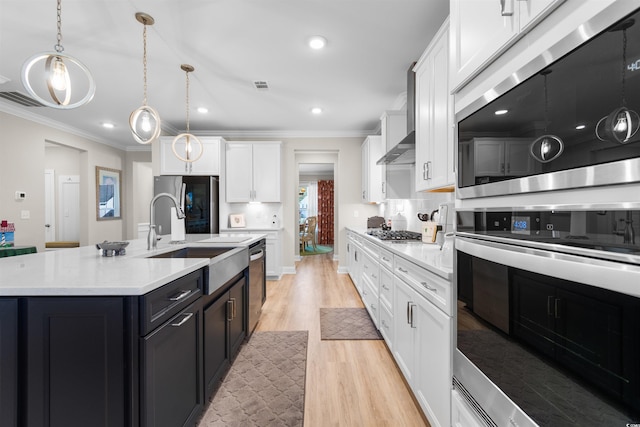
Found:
<box><xmin>320</xmin><ymin>308</ymin><xmax>382</xmax><ymax>340</ymax></box>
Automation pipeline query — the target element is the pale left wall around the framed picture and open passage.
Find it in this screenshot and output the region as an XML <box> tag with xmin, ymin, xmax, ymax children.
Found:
<box><xmin>0</xmin><ymin>112</ymin><xmax>141</xmax><ymax>252</ymax></box>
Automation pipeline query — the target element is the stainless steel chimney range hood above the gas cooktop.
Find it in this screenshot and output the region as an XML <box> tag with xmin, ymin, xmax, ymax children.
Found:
<box><xmin>376</xmin><ymin>62</ymin><xmax>416</xmax><ymax>165</ymax></box>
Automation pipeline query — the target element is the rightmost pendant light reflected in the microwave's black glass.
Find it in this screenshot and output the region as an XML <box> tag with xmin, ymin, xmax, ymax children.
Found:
<box><xmin>596</xmin><ymin>19</ymin><xmax>640</xmax><ymax>144</ymax></box>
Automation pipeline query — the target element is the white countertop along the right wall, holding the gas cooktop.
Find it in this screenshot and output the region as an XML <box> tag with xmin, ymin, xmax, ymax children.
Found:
<box><xmin>349</xmin><ymin>228</ymin><xmax>453</xmax><ymax>281</ymax></box>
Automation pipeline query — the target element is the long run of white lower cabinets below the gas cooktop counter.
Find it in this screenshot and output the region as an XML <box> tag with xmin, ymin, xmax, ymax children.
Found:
<box><xmin>347</xmin><ymin>231</ymin><xmax>452</xmax><ymax>427</ymax></box>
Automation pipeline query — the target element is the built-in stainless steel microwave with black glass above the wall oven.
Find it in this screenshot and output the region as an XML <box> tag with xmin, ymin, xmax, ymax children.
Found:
<box><xmin>456</xmin><ymin>9</ymin><xmax>640</xmax><ymax>199</ymax></box>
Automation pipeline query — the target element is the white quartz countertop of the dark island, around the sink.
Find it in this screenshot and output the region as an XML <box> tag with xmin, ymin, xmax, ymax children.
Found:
<box><xmin>0</xmin><ymin>233</ymin><xmax>265</xmax><ymax>296</ymax></box>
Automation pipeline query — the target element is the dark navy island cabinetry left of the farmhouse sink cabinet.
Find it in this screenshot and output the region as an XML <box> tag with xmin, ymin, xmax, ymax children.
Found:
<box><xmin>0</xmin><ymin>269</ymin><xmax>210</xmax><ymax>427</ymax></box>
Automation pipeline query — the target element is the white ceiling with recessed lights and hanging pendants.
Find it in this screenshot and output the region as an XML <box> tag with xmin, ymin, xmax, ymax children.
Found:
<box><xmin>0</xmin><ymin>0</ymin><xmax>449</xmax><ymax>150</ymax></box>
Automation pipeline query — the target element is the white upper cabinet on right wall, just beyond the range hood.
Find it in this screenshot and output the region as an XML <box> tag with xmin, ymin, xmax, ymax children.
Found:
<box><xmin>361</xmin><ymin>135</ymin><xmax>385</xmax><ymax>203</ymax></box>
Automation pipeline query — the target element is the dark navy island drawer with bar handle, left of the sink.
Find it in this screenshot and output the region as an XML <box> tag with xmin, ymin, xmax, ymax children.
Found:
<box><xmin>140</xmin><ymin>270</ymin><xmax>203</xmax><ymax>335</ymax></box>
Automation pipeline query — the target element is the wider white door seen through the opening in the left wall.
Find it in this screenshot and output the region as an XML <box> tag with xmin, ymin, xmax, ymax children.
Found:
<box><xmin>58</xmin><ymin>175</ymin><xmax>80</xmax><ymax>242</ymax></box>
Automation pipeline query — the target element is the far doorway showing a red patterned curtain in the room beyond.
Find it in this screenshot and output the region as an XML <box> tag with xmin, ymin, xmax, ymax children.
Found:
<box><xmin>297</xmin><ymin>163</ymin><xmax>335</xmax><ymax>256</ymax></box>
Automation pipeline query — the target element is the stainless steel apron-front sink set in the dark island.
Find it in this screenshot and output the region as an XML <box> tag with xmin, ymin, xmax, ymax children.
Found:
<box><xmin>147</xmin><ymin>246</ymin><xmax>249</xmax><ymax>295</ymax></box>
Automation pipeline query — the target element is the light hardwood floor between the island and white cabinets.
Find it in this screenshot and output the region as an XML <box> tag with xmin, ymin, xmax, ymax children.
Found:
<box><xmin>256</xmin><ymin>254</ymin><xmax>429</xmax><ymax>427</ymax></box>
